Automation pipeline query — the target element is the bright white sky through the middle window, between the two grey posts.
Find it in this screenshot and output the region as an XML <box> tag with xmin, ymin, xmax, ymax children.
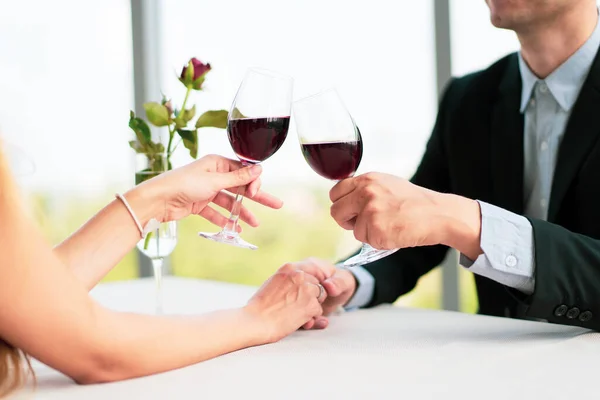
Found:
<box><xmin>163</xmin><ymin>0</ymin><xmax>436</xmax><ymax>185</ymax></box>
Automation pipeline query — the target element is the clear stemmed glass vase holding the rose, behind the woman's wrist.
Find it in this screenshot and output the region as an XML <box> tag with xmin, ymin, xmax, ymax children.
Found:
<box><xmin>135</xmin><ymin>153</ymin><xmax>177</xmax><ymax>314</ymax></box>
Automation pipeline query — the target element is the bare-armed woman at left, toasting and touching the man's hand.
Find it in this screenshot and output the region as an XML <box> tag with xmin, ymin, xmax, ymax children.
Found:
<box><xmin>0</xmin><ymin>144</ymin><xmax>327</xmax><ymax>397</ymax></box>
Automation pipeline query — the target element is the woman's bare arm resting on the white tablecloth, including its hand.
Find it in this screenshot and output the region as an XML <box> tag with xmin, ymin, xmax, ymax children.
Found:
<box><xmin>0</xmin><ymin>162</ymin><xmax>322</xmax><ymax>383</ymax></box>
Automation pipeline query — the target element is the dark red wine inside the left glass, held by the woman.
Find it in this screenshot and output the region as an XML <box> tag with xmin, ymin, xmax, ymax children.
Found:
<box><xmin>227</xmin><ymin>117</ymin><xmax>290</xmax><ymax>164</ymax></box>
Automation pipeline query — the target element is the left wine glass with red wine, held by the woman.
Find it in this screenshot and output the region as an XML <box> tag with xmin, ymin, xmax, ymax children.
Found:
<box><xmin>198</xmin><ymin>68</ymin><xmax>294</xmax><ymax>250</ymax></box>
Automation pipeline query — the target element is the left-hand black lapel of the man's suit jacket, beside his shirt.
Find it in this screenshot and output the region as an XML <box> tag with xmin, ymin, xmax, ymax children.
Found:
<box><xmin>490</xmin><ymin>54</ymin><xmax>524</xmax><ymax>214</ymax></box>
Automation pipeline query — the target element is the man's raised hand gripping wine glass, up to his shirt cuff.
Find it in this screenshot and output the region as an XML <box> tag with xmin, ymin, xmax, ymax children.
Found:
<box><xmin>330</xmin><ymin>173</ymin><xmax>481</xmax><ymax>259</ymax></box>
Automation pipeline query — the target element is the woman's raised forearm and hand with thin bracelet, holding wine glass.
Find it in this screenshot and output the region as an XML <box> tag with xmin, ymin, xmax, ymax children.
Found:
<box><xmin>54</xmin><ymin>156</ymin><xmax>281</xmax><ymax>290</ymax></box>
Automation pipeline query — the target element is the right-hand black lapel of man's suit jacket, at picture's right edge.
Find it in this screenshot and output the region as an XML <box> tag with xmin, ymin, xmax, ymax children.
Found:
<box><xmin>548</xmin><ymin>52</ymin><xmax>600</xmax><ymax>222</ymax></box>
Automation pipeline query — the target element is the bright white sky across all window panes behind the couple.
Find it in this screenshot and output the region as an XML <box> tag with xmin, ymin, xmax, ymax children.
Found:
<box><xmin>0</xmin><ymin>0</ymin><xmax>518</xmax><ymax>196</ymax></box>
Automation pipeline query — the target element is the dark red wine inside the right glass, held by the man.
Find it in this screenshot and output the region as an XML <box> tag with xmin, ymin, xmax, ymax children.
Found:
<box><xmin>302</xmin><ymin>140</ymin><xmax>362</xmax><ymax>181</ymax></box>
